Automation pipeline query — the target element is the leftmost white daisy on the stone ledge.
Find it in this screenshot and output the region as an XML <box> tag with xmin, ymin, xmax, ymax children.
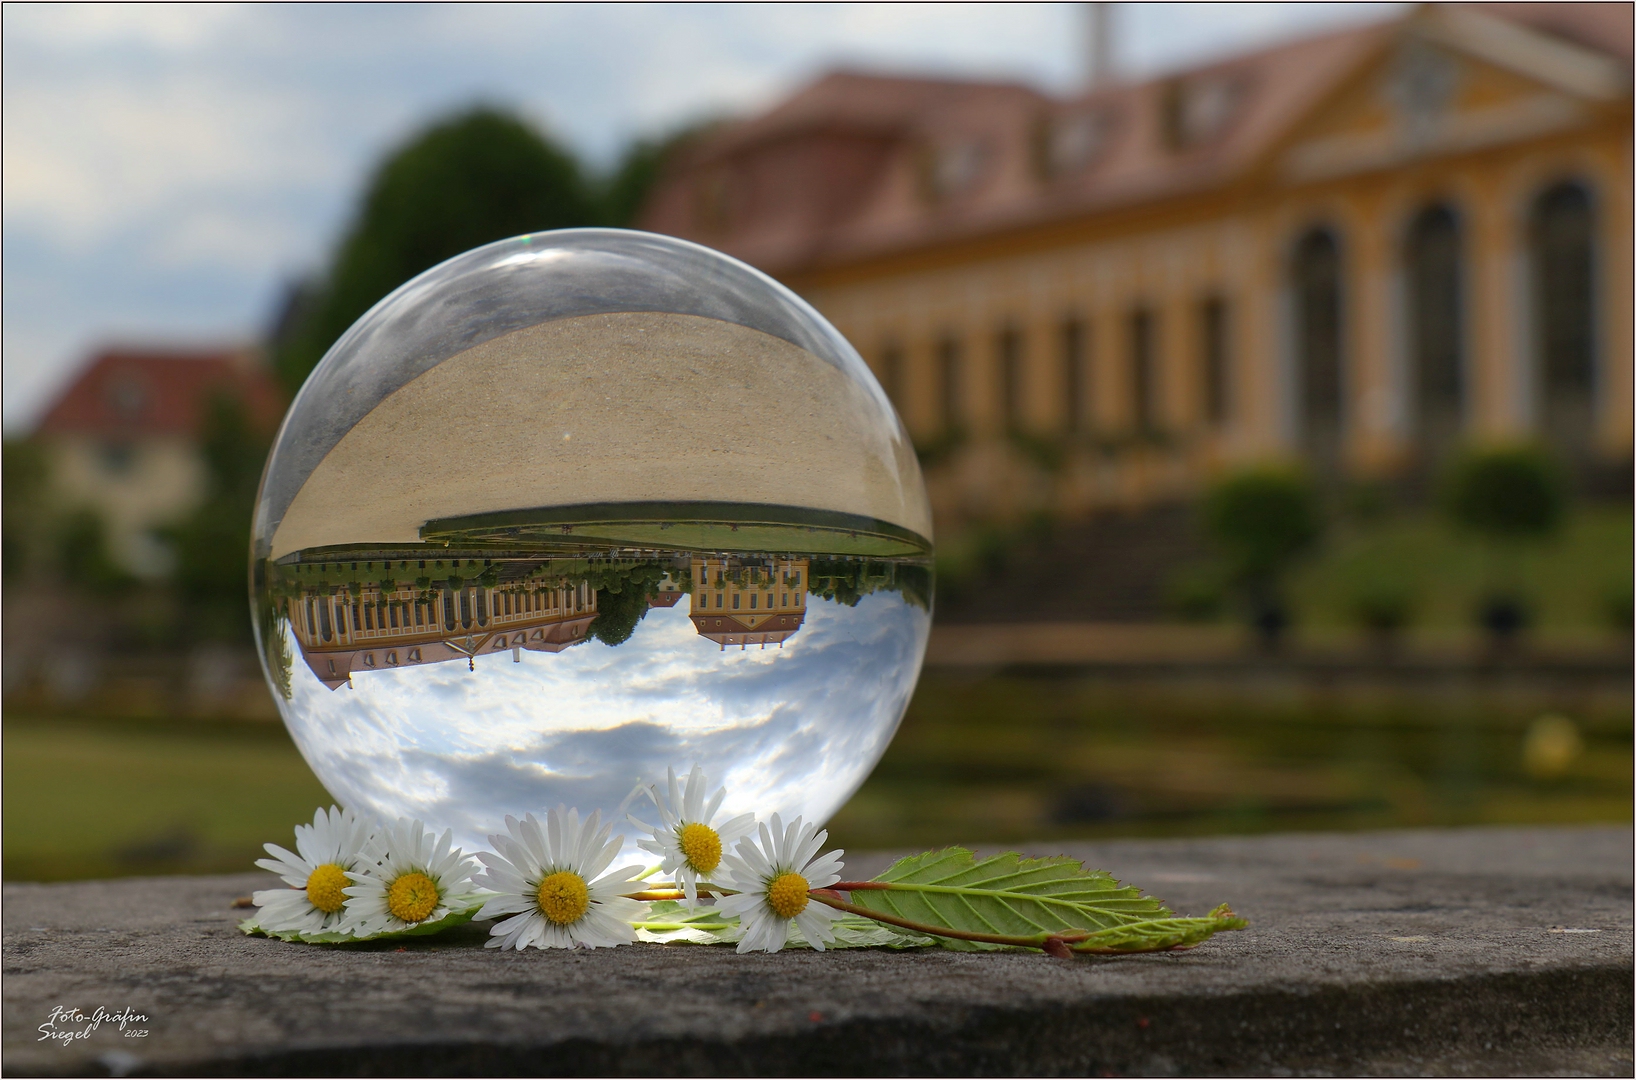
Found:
<box><xmin>250</xmin><ymin>807</ymin><xmax>375</xmax><ymax>934</ymax></box>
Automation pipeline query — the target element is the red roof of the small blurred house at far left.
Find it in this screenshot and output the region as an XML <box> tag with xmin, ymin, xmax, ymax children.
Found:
<box><xmin>39</xmin><ymin>349</ymin><xmax>288</xmax><ymax>437</ymax></box>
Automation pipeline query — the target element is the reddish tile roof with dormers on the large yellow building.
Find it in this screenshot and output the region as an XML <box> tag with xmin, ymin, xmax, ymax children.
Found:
<box><xmin>641</xmin><ymin>3</ymin><xmax>1631</xmax><ymax>273</ymax></box>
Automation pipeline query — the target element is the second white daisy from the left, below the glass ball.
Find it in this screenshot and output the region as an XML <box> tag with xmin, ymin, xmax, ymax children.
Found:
<box><xmin>344</xmin><ymin>818</ymin><xmax>486</xmax><ymax>938</ymax></box>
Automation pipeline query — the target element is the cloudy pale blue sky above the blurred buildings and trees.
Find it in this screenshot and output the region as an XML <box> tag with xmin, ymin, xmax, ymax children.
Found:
<box><xmin>3</xmin><ymin>3</ymin><xmax>1402</xmax><ymax>425</ymax></box>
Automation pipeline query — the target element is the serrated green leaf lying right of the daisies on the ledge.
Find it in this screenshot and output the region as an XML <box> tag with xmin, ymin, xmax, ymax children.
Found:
<box><xmin>852</xmin><ymin>848</ymin><xmax>1197</xmax><ymax>949</ymax></box>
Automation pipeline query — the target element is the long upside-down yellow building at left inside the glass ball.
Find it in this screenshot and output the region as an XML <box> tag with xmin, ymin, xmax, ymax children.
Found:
<box><xmin>285</xmin><ymin>581</ymin><xmax>597</xmax><ymax>691</ymax></box>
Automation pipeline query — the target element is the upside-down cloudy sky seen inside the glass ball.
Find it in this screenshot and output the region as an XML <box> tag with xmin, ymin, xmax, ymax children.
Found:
<box><xmin>274</xmin><ymin>592</ymin><xmax>929</xmax><ymax>846</ymax></box>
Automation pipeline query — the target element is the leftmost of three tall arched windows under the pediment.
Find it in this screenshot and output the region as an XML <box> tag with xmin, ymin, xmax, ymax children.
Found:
<box><xmin>1291</xmin><ymin>229</ymin><xmax>1345</xmax><ymax>476</ymax></box>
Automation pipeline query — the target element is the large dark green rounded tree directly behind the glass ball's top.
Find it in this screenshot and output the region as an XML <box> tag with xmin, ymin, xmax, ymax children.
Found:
<box><xmin>273</xmin><ymin>108</ymin><xmax>602</xmax><ymax>389</ymax></box>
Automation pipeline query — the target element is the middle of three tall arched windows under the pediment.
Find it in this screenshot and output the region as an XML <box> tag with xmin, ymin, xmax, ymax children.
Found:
<box><xmin>1404</xmin><ymin>206</ymin><xmax>1466</xmax><ymax>468</ymax></box>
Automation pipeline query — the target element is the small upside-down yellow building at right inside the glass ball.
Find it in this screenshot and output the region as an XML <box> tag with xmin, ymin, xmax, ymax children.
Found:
<box><xmin>689</xmin><ymin>556</ymin><xmax>808</xmax><ymax>650</ymax></box>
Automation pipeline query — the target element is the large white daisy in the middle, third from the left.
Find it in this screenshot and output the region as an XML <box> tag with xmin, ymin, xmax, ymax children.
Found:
<box><xmin>478</xmin><ymin>807</ymin><xmax>643</xmax><ymax>951</ymax></box>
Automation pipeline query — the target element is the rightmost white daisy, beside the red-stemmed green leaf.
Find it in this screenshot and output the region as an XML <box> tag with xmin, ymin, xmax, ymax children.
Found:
<box><xmin>717</xmin><ymin>813</ymin><xmax>841</xmax><ymax>952</ymax></box>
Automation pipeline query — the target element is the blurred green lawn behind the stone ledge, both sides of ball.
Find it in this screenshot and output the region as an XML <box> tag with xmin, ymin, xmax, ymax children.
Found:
<box><xmin>3</xmin><ymin>671</ymin><xmax>1631</xmax><ymax>880</ymax></box>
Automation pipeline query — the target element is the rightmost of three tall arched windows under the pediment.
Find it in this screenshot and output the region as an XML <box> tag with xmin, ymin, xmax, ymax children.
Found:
<box><xmin>1530</xmin><ymin>183</ymin><xmax>1597</xmax><ymax>458</ymax></box>
